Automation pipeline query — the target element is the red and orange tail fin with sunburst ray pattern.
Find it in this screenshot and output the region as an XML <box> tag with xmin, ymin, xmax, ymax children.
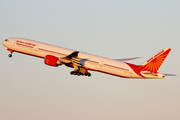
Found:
<box><xmin>141</xmin><ymin>48</ymin><xmax>171</xmax><ymax>73</ymax></box>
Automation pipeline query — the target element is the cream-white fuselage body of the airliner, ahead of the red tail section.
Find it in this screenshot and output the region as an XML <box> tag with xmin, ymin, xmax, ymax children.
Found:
<box><xmin>2</xmin><ymin>38</ymin><xmax>165</xmax><ymax>78</ymax></box>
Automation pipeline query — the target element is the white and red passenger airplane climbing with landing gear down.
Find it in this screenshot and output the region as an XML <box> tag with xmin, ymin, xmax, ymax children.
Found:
<box><xmin>2</xmin><ymin>38</ymin><xmax>171</xmax><ymax>79</ymax></box>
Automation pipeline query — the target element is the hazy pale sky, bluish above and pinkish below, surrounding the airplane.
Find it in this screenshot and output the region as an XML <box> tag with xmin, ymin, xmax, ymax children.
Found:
<box><xmin>0</xmin><ymin>0</ymin><xmax>180</xmax><ymax>120</ymax></box>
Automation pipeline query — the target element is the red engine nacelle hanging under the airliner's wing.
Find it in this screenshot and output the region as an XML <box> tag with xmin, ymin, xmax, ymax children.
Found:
<box><xmin>44</xmin><ymin>55</ymin><xmax>63</xmax><ymax>67</ymax></box>
